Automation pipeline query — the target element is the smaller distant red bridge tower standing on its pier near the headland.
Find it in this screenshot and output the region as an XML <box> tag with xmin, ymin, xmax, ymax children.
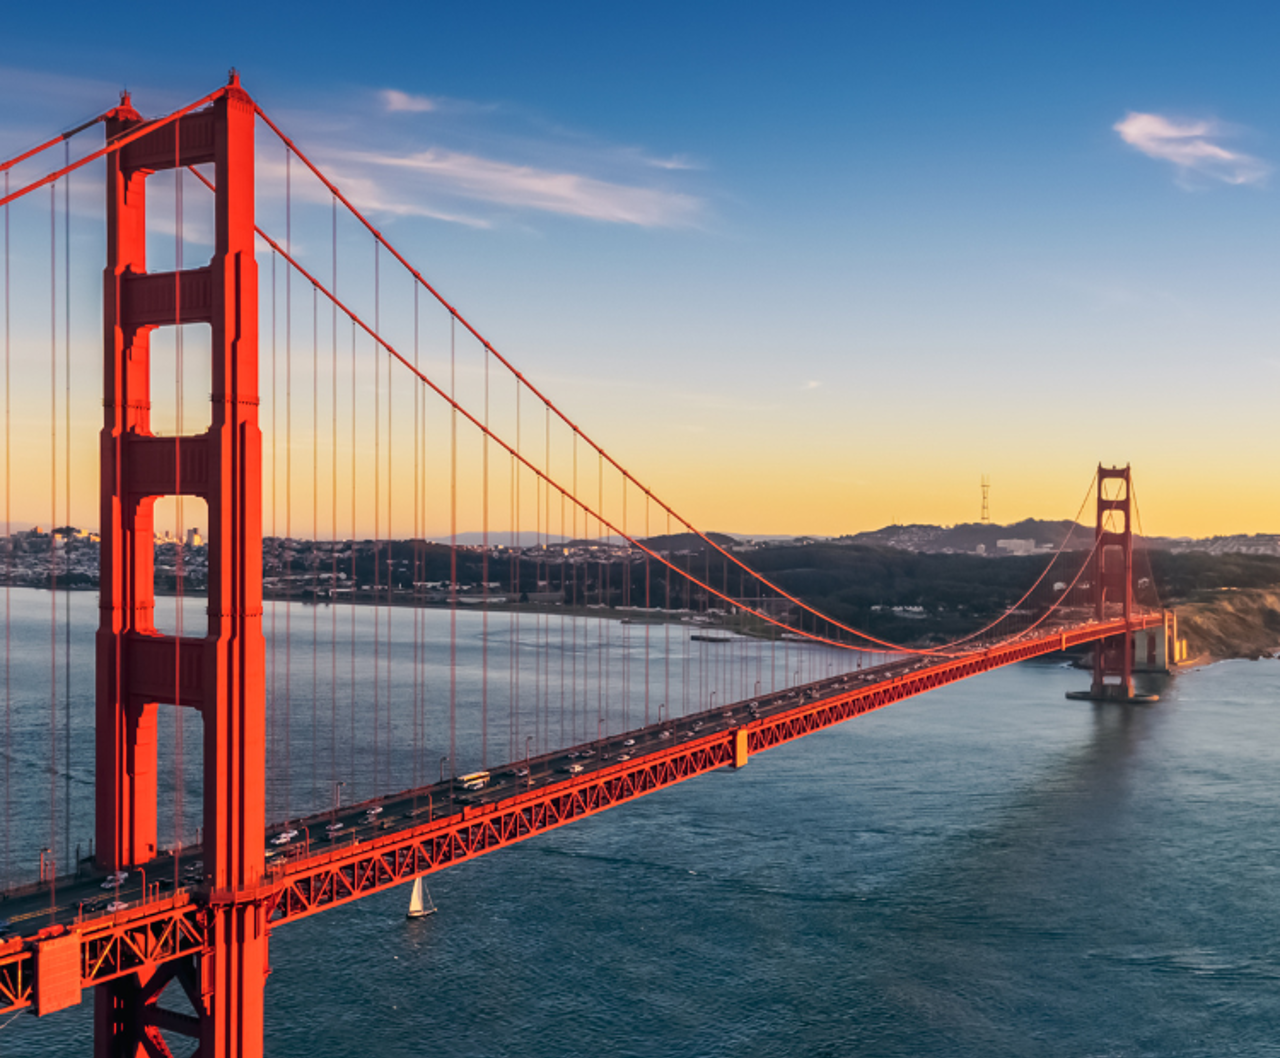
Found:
<box><xmin>1068</xmin><ymin>463</ymin><xmax>1157</xmax><ymax>702</ymax></box>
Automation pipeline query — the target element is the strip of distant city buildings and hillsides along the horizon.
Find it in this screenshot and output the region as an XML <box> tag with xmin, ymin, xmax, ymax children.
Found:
<box><xmin>0</xmin><ymin>522</ymin><xmax>1280</xmax><ymax>598</ymax></box>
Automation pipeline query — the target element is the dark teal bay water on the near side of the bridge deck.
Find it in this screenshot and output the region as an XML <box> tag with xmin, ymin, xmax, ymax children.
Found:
<box><xmin>0</xmin><ymin>591</ymin><xmax>1280</xmax><ymax>1058</ymax></box>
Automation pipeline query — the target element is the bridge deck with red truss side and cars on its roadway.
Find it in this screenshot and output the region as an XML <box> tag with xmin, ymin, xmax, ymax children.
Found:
<box><xmin>0</xmin><ymin>613</ymin><xmax>1162</xmax><ymax>1016</ymax></box>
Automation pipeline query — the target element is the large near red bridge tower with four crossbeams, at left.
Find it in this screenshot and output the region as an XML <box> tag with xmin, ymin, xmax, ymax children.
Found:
<box><xmin>93</xmin><ymin>75</ymin><xmax>269</xmax><ymax>1058</ymax></box>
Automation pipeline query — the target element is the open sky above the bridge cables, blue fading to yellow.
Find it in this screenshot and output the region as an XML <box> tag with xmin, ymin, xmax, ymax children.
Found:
<box><xmin>0</xmin><ymin>4</ymin><xmax>1280</xmax><ymax>535</ymax></box>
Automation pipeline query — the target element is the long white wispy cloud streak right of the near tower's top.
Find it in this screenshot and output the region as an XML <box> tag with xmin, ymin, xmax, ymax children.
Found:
<box><xmin>344</xmin><ymin>148</ymin><xmax>700</xmax><ymax>228</ymax></box>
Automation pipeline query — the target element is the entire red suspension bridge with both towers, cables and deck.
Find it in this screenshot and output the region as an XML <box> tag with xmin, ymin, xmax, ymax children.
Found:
<box><xmin>0</xmin><ymin>74</ymin><xmax>1170</xmax><ymax>1058</ymax></box>
